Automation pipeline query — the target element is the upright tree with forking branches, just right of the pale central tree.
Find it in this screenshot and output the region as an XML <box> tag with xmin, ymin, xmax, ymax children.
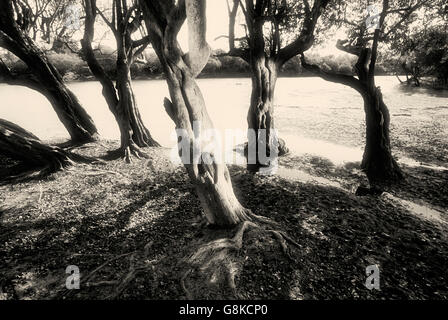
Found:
<box><xmin>238</xmin><ymin>0</ymin><xmax>329</xmax><ymax>173</ymax></box>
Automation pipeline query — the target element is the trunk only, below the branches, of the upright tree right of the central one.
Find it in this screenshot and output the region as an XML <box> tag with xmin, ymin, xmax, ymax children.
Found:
<box><xmin>246</xmin><ymin>56</ymin><xmax>288</xmax><ymax>172</ymax></box>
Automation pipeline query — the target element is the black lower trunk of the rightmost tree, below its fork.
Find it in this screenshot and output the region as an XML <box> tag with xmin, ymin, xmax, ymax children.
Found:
<box><xmin>361</xmin><ymin>87</ymin><xmax>403</xmax><ymax>184</ymax></box>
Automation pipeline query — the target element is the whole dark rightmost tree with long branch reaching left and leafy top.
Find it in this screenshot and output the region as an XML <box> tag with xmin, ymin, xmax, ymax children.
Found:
<box><xmin>301</xmin><ymin>0</ymin><xmax>430</xmax><ymax>186</ymax></box>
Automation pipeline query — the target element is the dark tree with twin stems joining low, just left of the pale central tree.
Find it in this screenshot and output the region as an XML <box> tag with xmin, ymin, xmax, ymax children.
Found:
<box><xmin>81</xmin><ymin>0</ymin><xmax>159</xmax><ymax>162</ymax></box>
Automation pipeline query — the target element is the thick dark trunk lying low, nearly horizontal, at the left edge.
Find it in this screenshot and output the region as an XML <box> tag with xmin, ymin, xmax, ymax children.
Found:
<box><xmin>0</xmin><ymin>119</ymin><xmax>89</xmax><ymax>175</ymax></box>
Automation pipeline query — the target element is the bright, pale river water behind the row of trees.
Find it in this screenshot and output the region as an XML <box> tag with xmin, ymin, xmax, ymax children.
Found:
<box><xmin>0</xmin><ymin>76</ymin><xmax>448</xmax><ymax>163</ymax></box>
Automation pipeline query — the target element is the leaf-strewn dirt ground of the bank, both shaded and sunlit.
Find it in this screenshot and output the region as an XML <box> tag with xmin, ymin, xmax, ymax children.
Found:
<box><xmin>0</xmin><ymin>141</ymin><xmax>448</xmax><ymax>299</ymax></box>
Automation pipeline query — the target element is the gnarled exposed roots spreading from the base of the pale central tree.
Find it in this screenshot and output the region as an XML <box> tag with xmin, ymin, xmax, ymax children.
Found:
<box><xmin>180</xmin><ymin>219</ymin><xmax>299</xmax><ymax>299</ymax></box>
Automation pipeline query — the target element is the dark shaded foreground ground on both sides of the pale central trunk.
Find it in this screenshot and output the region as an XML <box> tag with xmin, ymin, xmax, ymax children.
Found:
<box><xmin>0</xmin><ymin>166</ymin><xmax>448</xmax><ymax>299</ymax></box>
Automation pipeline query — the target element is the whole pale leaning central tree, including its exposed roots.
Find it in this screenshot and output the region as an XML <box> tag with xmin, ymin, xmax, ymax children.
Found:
<box><xmin>140</xmin><ymin>0</ymin><xmax>295</xmax><ymax>299</ymax></box>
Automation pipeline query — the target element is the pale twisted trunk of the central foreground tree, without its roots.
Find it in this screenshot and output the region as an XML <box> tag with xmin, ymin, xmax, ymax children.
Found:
<box><xmin>141</xmin><ymin>0</ymin><xmax>251</xmax><ymax>227</ymax></box>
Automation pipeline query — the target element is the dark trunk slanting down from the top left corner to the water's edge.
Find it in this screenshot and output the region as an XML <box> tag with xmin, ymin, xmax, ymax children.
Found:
<box><xmin>0</xmin><ymin>0</ymin><xmax>98</xmax><ymax>143</ymax></box>
